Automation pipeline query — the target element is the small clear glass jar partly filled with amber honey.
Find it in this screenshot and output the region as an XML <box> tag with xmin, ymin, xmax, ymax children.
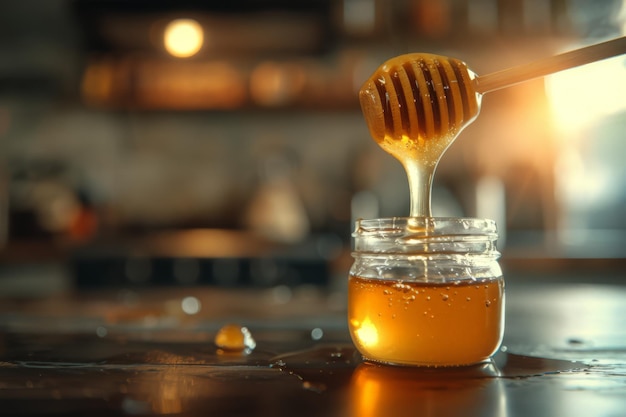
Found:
<box><xmin>348</xmin><ymin>217</ymin><xmax>504</xmax><ymax>366</ymax></box>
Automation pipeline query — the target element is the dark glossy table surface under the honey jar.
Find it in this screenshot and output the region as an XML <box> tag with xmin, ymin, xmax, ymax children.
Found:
<box><xmin>0</xmin><ymin>283</ymin><xmax>626</xmax><ymax>417</ymax></box>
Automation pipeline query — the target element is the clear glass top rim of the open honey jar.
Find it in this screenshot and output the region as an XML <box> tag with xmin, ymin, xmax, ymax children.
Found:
<box><xmin>352</xmin><ymin>217</ymin><xmax>498</xmax><ymax>237</ymax></box>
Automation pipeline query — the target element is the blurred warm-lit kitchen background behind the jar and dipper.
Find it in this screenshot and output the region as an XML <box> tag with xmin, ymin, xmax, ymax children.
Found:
<box><xmin>0</xmin><ymin>0</ymin><xmax>626</xmax><ymax>296</ymax></box>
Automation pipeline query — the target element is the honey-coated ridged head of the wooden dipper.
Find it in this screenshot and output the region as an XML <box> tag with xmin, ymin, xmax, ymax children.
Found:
<box><xmin>359</xmin><ymin>53</ymin><xmax>480</xmax><ymax>163</ymax></box>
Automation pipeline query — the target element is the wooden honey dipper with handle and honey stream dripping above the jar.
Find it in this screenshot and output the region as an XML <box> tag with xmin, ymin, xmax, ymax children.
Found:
<box><xmin>359</xmin><ymin>37</ymin><xmax>626</xmax><ymax>216</ymax></box>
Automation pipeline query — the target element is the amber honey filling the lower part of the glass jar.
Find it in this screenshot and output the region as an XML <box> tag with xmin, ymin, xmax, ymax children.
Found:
<box><xmin>348</xmin><ymin>276</ymin><xmax>504</xmax><ymax>366</ymax></box>
